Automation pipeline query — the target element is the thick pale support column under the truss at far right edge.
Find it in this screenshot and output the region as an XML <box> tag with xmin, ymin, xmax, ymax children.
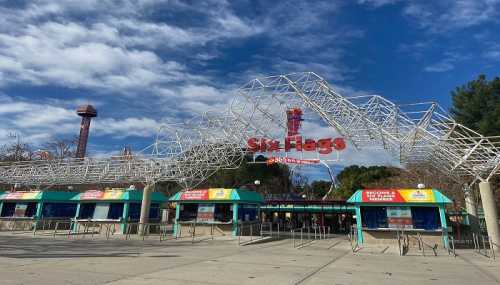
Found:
<box><xmin>479</xmin><ymin>182</ymin><xmax>500</xmax><ymax>249</ymax></box>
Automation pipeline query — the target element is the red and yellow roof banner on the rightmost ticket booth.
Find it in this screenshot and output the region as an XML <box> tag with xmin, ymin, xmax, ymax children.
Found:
<box><xmin>361</xmin><ymin>189</ymin><xmax>436</xmax><ymax>203</ymax></box>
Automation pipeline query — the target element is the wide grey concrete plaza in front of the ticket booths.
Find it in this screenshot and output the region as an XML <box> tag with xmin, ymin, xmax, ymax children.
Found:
<box><xmin>0</xmin><ymin>233</ymin><xmax>500</xmax><ymax>285</ymax></box>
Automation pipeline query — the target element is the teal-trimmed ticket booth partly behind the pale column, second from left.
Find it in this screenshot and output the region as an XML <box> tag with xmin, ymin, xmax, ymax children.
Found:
<box><xmin>73</xmin><ymin>188</ymin><xmax>168</xmax><ymax>233</ymax></box>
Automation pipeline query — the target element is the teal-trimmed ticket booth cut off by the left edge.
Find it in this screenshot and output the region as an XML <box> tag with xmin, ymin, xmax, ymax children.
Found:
<box><xmin>0</xmin><ymin>191</ymin><xmax>78</xmax><ymax>228</ymax></box>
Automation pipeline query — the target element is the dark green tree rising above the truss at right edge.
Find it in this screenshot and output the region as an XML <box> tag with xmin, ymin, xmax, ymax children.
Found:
<box><xmin>450</xmin><ymin>75</ymin><xmax>500</xmax><ymax>136</ymax></box>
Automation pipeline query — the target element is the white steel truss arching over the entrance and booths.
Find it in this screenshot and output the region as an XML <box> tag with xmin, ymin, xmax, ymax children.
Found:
<box><xmin>0</xmin><ymin>72</ymin><xmax>500</xmax><ymax>188</ymax></box>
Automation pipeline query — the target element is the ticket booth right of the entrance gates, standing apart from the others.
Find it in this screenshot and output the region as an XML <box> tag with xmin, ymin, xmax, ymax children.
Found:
<box><xmin>347</xmin><ymin>189</ymin><xmax>452</xmax><ymax>247</ymax></box>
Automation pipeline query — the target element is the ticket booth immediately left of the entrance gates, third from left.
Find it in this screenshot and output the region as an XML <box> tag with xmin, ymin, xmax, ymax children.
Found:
<box><xmin>170</xmin><ymin>188</ymin><xmax>263</xmax><ymax>236</ymax></box>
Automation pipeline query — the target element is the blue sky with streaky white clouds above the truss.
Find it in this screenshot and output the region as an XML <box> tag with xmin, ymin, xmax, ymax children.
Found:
<box><xmin>0</xmin><ymin>0</ymin><xmax>500</xmax><ymax>178</ymax></box>
